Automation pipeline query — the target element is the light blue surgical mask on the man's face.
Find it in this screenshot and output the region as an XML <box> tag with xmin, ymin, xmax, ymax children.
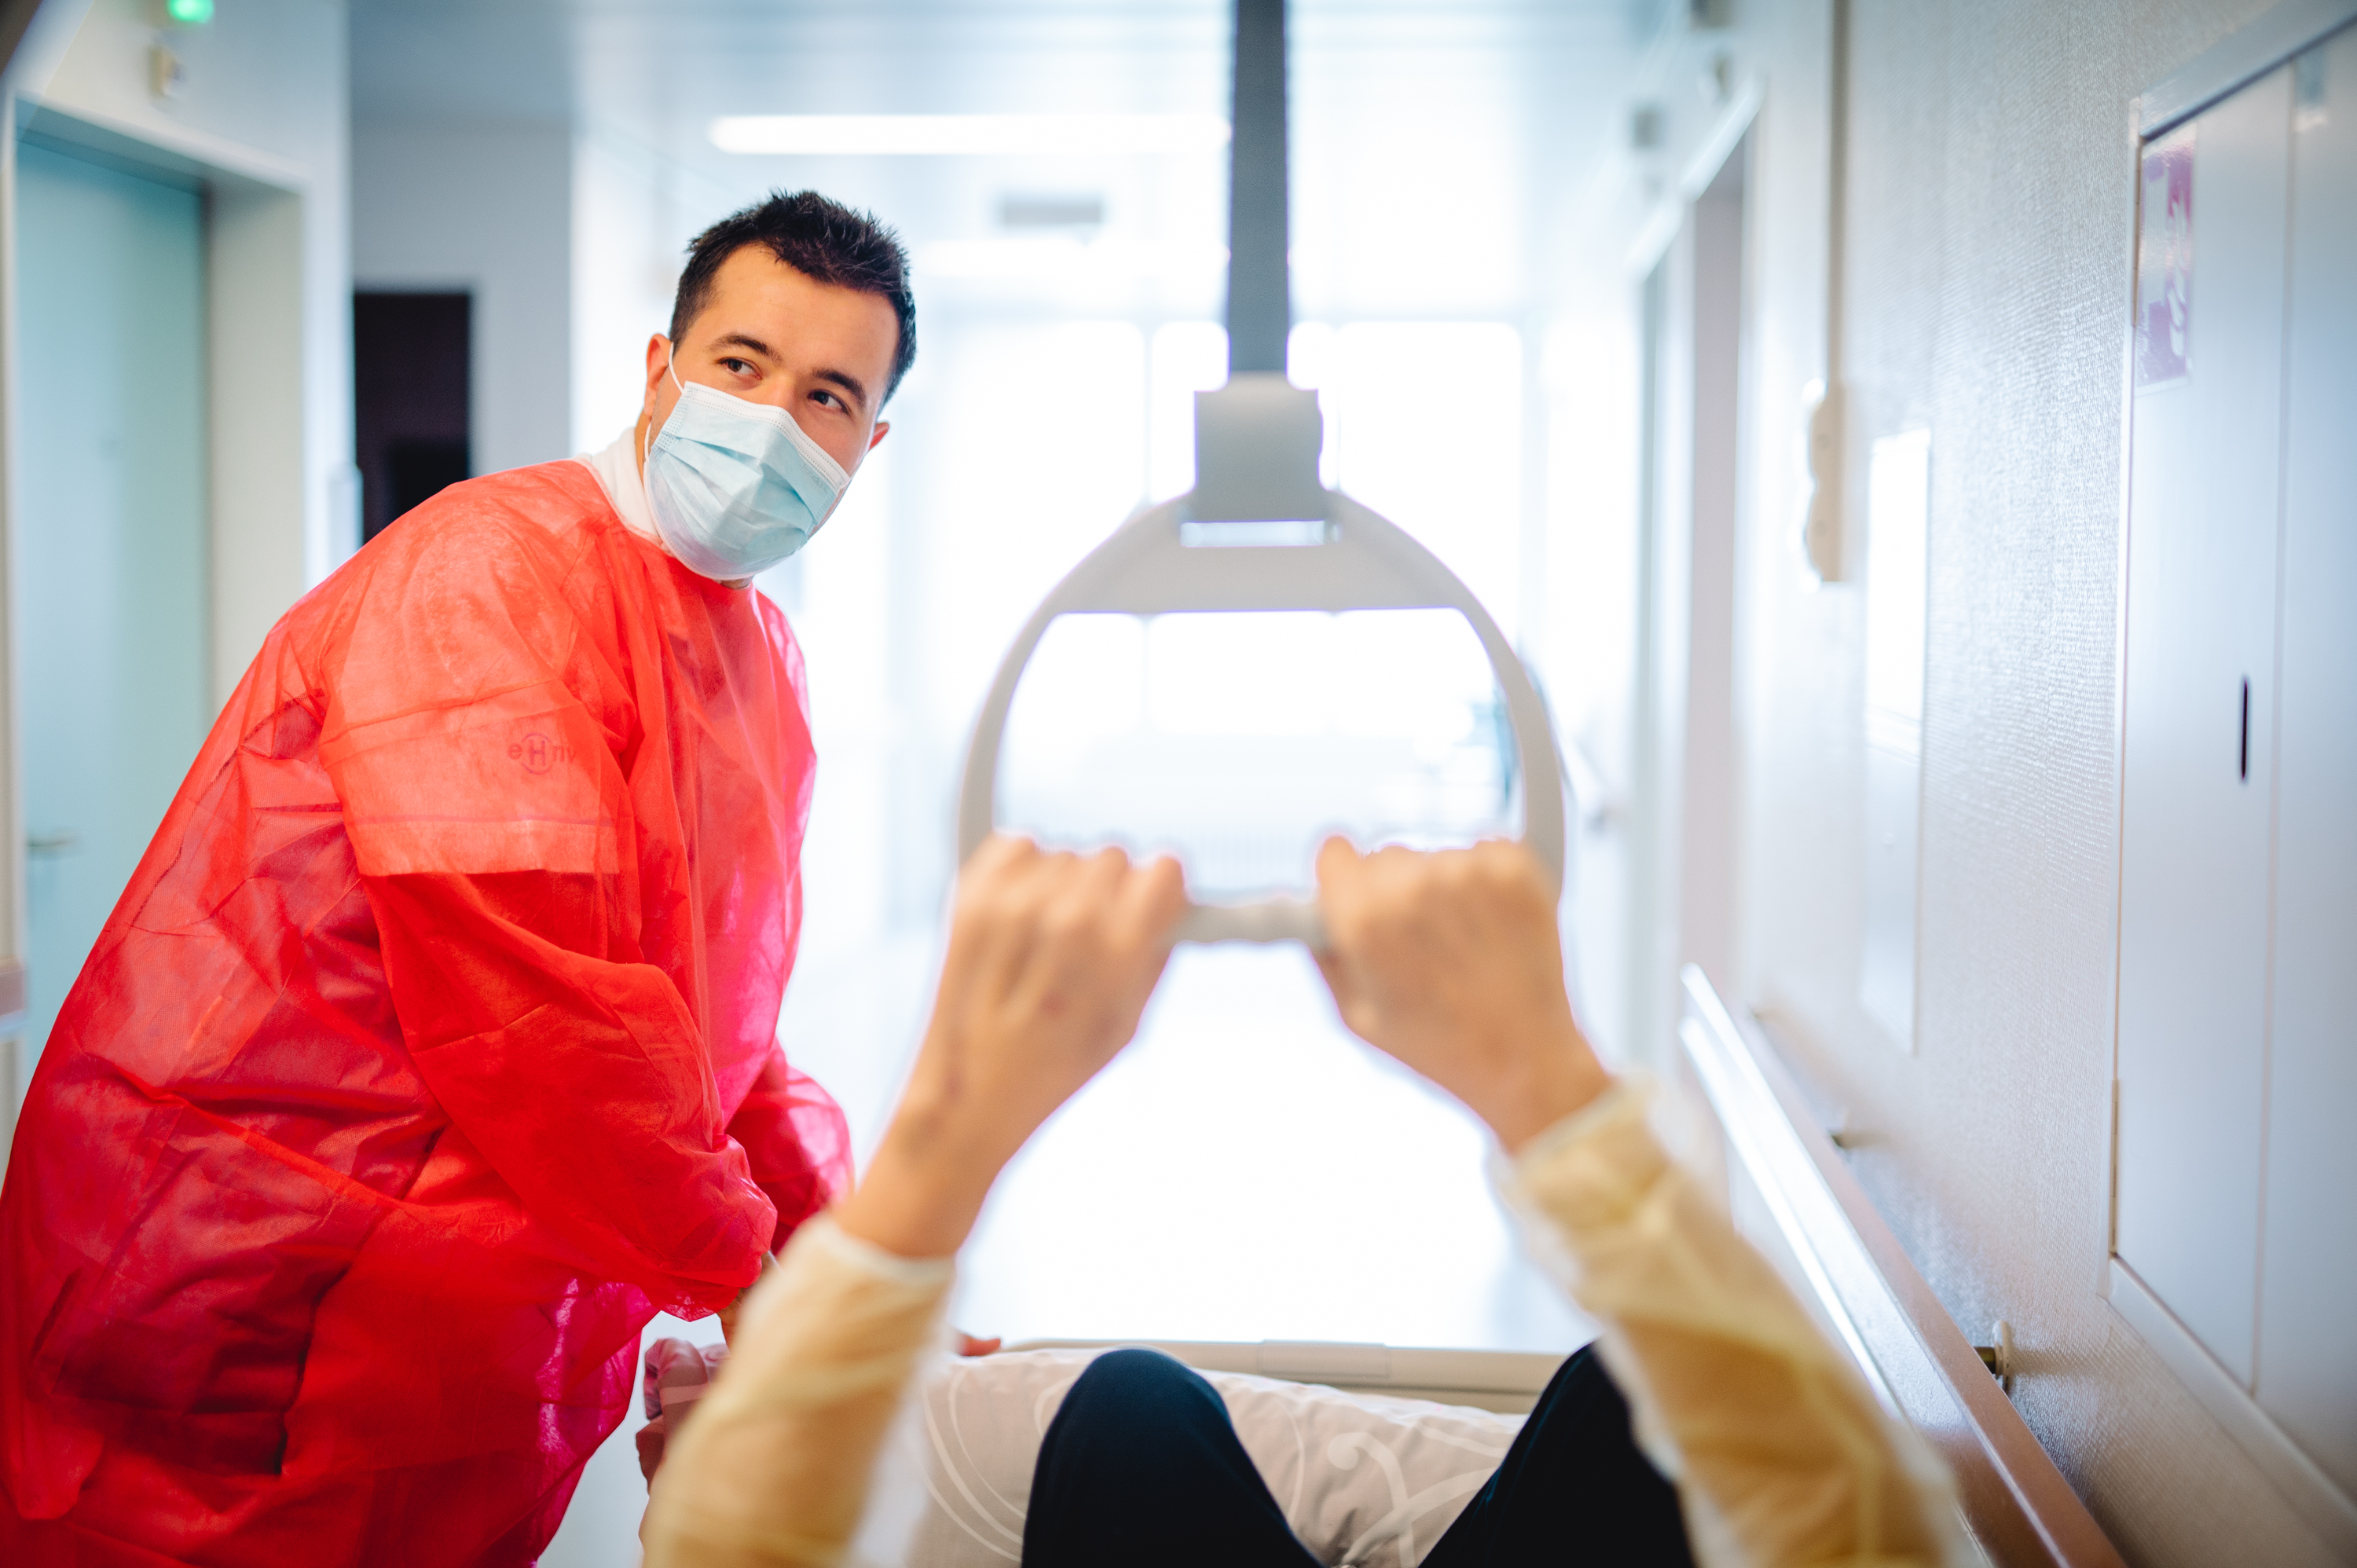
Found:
<box><xmin>646</xmin><ymin>358</ymin><xmax>851</xmax><ymax>582</ymax></box>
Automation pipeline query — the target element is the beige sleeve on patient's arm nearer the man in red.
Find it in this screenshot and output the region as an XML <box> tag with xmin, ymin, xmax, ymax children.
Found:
<box><xmin>641</xmin><ymin>1214</ymin><xmax>955</xmax><ymax>1568</ymax></box>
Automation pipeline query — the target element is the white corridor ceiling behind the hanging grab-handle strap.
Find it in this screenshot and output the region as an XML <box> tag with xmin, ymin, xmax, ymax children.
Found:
<box><xmin>351</xmin><ymin>0</ymin><xmax>1666</xmax><ymax>318</ymax></box>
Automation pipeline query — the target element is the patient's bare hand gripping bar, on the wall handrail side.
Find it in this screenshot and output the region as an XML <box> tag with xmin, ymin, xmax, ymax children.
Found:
<box><xmin>1318</xmin><ymin>840</ymin><xmax>1607</xmax><ymax>1153</ymax></box>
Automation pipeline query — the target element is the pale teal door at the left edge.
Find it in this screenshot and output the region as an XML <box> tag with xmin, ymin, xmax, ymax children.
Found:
<box><xmin>12</xmin><ymin>137</ymin><xmax>212</xmax><ymax>1097</ymax></box>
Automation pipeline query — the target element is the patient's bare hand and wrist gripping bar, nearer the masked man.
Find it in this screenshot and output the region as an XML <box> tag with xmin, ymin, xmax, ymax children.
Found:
<box><xmin>837</xmin><ymin>837</ymin><xmax>1186</xmax><ymax>1257</ymax></box>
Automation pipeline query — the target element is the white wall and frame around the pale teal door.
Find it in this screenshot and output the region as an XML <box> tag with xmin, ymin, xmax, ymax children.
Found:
<box><xmin>0</xmin><ymin>0</ymin><xmax>358</xmax><ymax>1150</ymax></box>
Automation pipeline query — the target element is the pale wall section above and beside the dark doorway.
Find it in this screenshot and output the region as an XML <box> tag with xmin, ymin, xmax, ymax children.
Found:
<box><xmin>351</xmin><ymin>120</ymin><xmax>580</xmax><ymax>474</ymax></box>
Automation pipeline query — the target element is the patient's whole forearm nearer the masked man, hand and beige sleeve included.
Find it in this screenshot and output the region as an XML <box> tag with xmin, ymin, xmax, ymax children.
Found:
<box><xmin>643</xmin><ymin>835</ymin><xmax>1186</xmax><ymax>1568</ymax></box>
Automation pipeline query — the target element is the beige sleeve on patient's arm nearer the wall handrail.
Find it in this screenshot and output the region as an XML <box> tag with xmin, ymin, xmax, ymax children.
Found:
<box><xmin>1499</xmin><ymin>1083</ymin><xmax>1961</xmax><ymax>1568</ymax></box>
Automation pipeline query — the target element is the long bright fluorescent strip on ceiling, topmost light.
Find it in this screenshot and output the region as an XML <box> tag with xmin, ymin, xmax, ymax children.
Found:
<box><xmin>712</xmin><ymin>113</ymin><xmax>1228</xmax><ymax>156</ymax></box>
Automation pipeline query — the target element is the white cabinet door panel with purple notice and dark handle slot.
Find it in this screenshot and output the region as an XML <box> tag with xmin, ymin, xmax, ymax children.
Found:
<box><xmin>2119</xmin><ymin>71</ymin><xmax>2291</xmax><ymax>1387</ymax></box>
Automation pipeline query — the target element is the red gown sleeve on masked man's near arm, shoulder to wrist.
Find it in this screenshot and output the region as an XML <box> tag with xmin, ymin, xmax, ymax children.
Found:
<box><xmin>318</xmin><ymin>511</ymin><xmax>799</xmax><ymax>1313</ymax></box>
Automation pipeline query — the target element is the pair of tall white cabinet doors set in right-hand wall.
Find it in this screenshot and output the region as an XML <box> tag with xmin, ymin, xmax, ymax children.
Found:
<box><xmin>2114</xmin><ymin>31</ymin><xmax>2357</xmax><ymax>1518</ymax></box>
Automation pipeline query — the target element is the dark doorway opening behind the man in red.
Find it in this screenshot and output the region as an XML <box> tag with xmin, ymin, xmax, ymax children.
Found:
<box><xmin>351</xmin><ymin>292</ymin><xmax>474</xmax><ymax>544</ymax></box>
